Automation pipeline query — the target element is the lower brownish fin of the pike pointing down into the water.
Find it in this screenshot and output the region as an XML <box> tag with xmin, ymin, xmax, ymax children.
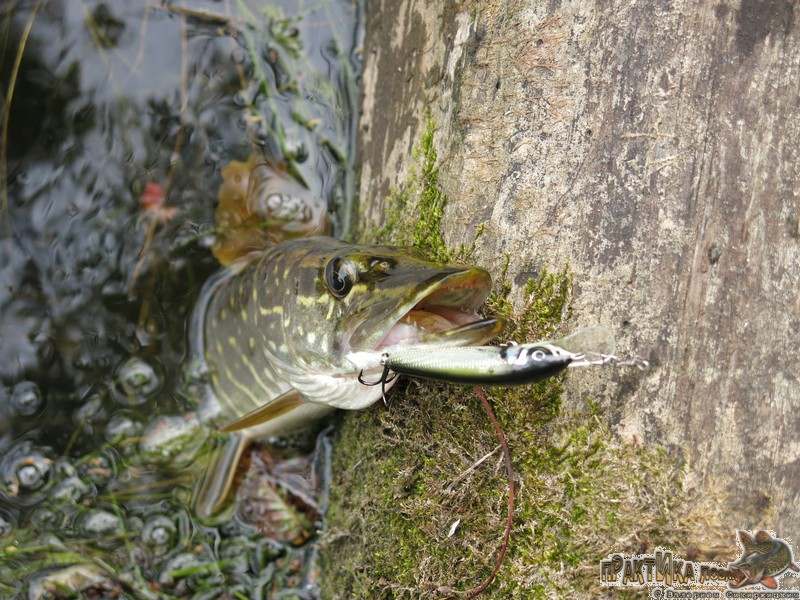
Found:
<box><xmin>194</xmin><ymin>434</ymin><xmax>249</xmax><ymax>519</ymax></box>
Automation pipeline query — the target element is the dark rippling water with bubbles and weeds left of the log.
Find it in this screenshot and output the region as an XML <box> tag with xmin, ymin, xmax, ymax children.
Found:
<box><xmin>0</xmin><ymin>0</ymin><xmax>361</xmax><ymax>598</ymax></box>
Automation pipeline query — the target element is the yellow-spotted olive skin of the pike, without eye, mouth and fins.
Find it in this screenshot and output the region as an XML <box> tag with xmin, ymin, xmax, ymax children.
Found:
<box><xmin>198</xmin><ymin>237</ymin><xmax>491</xmax><ymax>435</ymax></box>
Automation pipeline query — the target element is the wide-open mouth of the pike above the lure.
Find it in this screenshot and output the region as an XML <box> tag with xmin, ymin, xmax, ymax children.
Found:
<box><xmin>374</xmin><ymin>267</ymin><xmax>504</xmax><ymax>350</ymax></box>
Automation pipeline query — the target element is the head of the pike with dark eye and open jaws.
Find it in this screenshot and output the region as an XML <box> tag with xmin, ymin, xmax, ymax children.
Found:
<box><xmin>284</xmin><ymin>238</ymin><xmax>501</xmax><ymax>371</ymax></box>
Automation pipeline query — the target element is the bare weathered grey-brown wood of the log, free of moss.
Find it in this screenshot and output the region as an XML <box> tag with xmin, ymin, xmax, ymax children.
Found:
<box><xmin>360</xmin><ymin>0</ymin><xmax>800</xmax><ymax>539</ymax></box>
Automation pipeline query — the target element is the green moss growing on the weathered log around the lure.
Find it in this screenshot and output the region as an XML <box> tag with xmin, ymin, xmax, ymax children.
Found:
<box><xmin>322</xmin><ymin>121</ymin><xmax>722</xmax><ymax>598</ymax></box>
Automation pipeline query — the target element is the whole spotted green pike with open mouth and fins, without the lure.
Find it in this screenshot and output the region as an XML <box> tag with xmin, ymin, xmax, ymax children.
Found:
<box><xmin>191</xmin><ymin>237</ymin><xmax>502</xmax><ymax>516</ymax></box>
